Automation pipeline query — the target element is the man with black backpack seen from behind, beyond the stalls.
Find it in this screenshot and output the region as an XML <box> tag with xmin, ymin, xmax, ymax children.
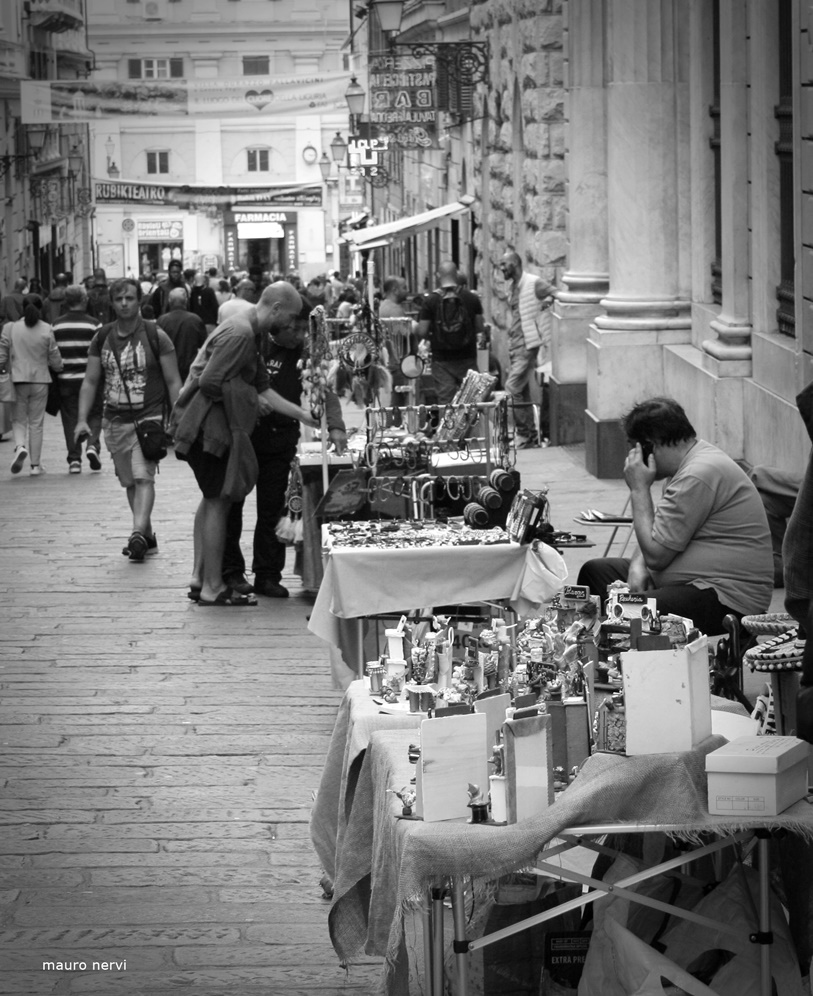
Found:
<box><xmin>418</xmin><ymin>263</ymin><xmax>483</xmax><ymax>405</ymax></box>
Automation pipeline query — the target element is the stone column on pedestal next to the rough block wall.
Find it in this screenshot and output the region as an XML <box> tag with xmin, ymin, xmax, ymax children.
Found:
<box><xmin>550</xmin><ymin>0</ymin><xmax>609</xmax><ymax>446</ymax></box>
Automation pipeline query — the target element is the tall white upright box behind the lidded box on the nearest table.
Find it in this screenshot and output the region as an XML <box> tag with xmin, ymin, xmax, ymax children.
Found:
<box><xmin>621</xmin><ymin>636</ymin><xmax>711</xmax><ymax>757</ymax></box>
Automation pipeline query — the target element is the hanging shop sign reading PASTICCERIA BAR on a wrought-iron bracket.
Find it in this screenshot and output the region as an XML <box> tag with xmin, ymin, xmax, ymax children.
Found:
<box><xmin>368</xmin><ymin>54</ymin><xmax>437</xmax><ymax>148</ymax></box>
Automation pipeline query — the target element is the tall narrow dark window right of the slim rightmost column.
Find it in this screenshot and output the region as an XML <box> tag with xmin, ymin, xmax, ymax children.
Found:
<box><xmin>774</xmin><ymin>0</ymin><xmax>796</xmax><ymax>336</ymax></box>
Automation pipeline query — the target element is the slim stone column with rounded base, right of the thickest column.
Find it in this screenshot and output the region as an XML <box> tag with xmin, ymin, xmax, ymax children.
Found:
<box><xmin>703</xmin><ymin>0</ymin><xmax>751</xmax><ymax>377</ymax></box>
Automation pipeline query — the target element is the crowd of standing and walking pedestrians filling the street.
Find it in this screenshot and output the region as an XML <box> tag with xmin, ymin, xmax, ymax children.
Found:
<box><xmin>0</xmin><ymin>257</ymin><xmax>576</xmax><ymax>605</ymax></box>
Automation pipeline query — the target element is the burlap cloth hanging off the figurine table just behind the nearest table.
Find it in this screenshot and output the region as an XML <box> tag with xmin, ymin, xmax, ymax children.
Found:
<box><xmin>310</xmin><ymin>681</ymin><xmax>425</xmax><ymax>879</ymax></box>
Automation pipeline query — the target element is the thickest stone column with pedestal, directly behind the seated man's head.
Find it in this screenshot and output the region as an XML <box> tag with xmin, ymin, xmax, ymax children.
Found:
<box><xmin>585</xmin><ymin>0</ymin><xmax>691</xmax><ymax>477</ymax></box>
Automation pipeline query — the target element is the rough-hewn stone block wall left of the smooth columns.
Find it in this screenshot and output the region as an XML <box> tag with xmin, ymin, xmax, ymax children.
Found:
<box><xmin>471</xmin><ymin>0</ymin><xmax>567</xmax><ymax>378</ymax></box>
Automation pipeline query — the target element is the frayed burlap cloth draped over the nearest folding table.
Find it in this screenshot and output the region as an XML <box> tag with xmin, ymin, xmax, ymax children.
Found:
<box><xmin>329</xmin><ymin>731</ymin><xmax>813</xmax><ymax>996</ymax></box>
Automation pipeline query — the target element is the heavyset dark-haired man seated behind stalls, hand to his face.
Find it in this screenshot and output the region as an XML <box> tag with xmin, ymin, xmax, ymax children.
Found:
<box><xmin>578</xmin><ymin>398</ymin><xmax>773</xmax><ymax>636</ymax></box>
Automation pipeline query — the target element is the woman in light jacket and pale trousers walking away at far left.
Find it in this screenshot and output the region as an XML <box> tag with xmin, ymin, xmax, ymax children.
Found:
<box><xmin>0</xmin><ymin>294</ymin><xmax>62</xmax><ymax>477</ymax></box>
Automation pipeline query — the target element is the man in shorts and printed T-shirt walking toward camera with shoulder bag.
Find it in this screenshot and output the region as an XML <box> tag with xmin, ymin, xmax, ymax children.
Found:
<box><xmin>75</xmin><ymin>278</ymin><xmax>181</xmax><ymax>562</ymax></box>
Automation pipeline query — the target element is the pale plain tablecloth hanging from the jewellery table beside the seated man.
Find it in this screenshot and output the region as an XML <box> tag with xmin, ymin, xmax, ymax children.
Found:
<box><xmin>308</xmin><ymin>527</ymin><xmax>567</xmax><ymax>688</ymax></box>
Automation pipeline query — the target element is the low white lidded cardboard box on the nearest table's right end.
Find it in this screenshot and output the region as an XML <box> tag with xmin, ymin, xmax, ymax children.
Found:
<box><xmin>706</xmin><ymin>737</ymin><xmax>810</xmax><ymax>816</ymax></box>
